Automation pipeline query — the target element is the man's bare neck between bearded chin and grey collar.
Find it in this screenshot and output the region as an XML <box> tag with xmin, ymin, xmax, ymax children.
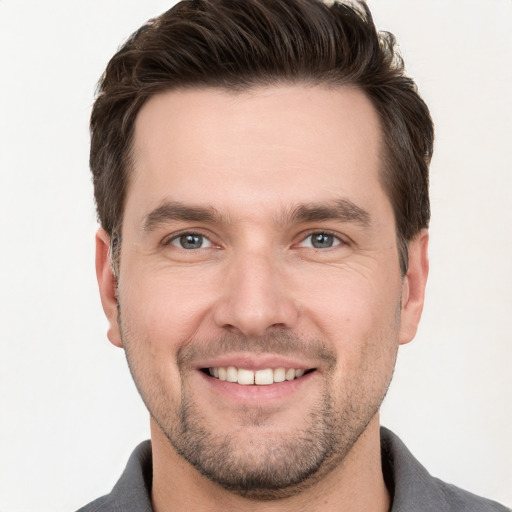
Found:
<box><xmin>151</xmin><ymin>414</ymin><xmax>390</xmax><ymax>512</ymax></box>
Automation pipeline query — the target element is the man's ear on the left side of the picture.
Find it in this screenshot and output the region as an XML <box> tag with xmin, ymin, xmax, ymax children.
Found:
<box><xmin>96</xmin><ymin>228</ymin><xmax>123</xmax><ymax>347</ymax></box>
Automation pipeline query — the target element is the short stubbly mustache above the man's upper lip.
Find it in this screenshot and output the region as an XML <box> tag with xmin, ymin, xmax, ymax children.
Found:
<box><xmin>176</xmin><ymin>331</ymin><xmax>336</xmax><ymax>369</ymax></box>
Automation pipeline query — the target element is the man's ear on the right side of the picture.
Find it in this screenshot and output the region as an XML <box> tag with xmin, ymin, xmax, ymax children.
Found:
<box><xmin>400</xmin><ymin>229</ymin><xmax>428</xmax><ymax>345</ymax></box>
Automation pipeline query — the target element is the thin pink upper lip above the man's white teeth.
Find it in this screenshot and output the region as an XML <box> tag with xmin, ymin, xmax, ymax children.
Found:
<box><xmin>197</xmin><ymin>354</ymin><xmax>316</xmax><ymax>371</ymax></box>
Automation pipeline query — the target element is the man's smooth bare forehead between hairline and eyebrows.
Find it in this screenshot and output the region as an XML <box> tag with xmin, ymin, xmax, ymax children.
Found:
<box><xmin>127</xmin><ymin>85</ymin><xmax>382</xmax><ymax>223</ymax></box>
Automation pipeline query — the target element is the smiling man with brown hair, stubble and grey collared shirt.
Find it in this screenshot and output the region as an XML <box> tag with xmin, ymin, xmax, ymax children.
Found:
<box><xmin>78</xmin><ymin>0</ymin><xmax>506</xmax><ymax>512</ymax></box>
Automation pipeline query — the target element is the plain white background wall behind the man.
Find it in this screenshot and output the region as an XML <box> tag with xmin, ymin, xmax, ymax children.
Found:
<box><xmin>0</xmin><ymin>0</ymin><xmax>512</xmax><ymax>512</ymax></box>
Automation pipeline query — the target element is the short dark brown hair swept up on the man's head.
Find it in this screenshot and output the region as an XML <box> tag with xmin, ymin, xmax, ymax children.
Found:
<box><xmin>90</xmin><ymin>0</ymin><xmax>434</xmax><ymax>274</ymax></box>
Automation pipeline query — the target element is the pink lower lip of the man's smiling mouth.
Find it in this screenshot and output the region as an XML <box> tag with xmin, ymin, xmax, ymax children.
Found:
<box><xmin>198</xmin><ymin>371</ymin><xmax>316</xmax><ymax>405</ymax></box>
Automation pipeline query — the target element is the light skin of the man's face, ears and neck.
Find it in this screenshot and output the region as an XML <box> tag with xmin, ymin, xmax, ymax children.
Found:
<box><xmin>96</xmin><ymin>85</ymin><xmax>428</xmax><ymax>512</ymax></box>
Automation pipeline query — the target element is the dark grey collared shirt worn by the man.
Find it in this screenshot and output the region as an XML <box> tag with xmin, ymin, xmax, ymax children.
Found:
<box><xmin>78</xmin><ymin>427</ymin><xmax>511</xmax><ymax>512</ymax></box>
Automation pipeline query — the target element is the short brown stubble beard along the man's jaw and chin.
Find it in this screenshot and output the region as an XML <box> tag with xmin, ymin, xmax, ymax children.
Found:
<box><xmin>121</xmin><ymin>328</ymin><xmax>391</xmax><ymax>501</ymax></box>
